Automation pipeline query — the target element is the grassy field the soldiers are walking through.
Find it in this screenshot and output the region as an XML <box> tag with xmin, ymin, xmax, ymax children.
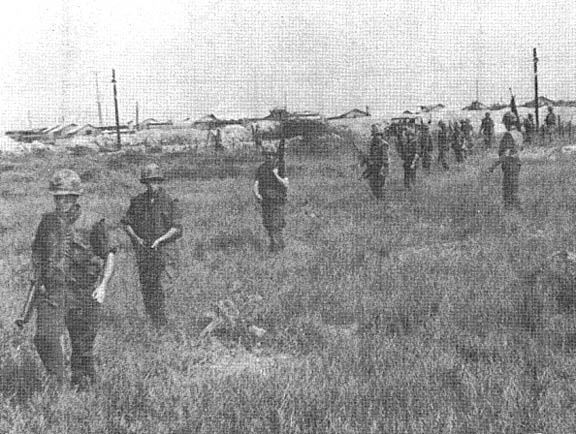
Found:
<box><xmin>0</xmin><ymin>134</ymin><xmax>576</xmax><ymax>434</ymax></box>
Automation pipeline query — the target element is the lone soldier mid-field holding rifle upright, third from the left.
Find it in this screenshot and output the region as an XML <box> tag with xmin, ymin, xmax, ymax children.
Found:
<box><xmin>252</xmin><ymin>144</ymin><xmax>288</xmax><ymax>252</ymax></box>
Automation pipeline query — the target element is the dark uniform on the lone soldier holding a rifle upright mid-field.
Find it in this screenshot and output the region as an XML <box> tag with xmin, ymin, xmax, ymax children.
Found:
<box><xmin>255</xmin><ymin>154</ymin><xmax>287</xmax><ymax>252</ymax></box>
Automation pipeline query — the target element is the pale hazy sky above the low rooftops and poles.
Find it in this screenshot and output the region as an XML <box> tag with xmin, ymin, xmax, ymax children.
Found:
<box><xmin>0</xmin><ymin>0</ymin><xmax>576</xmax><ymax>130</ymax></box>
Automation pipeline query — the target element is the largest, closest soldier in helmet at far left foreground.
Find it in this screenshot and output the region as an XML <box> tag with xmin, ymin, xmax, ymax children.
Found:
<box><xmin>32</xmin><ymin>169</ymin><xmax>116</xmax><ymax>389</ymax></box>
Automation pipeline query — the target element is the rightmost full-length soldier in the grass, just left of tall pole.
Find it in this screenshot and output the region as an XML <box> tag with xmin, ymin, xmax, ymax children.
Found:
<box><xmin>490</xmin><ymin>112</ymin><xmax>522</xmax><ymax>209</ymax></box>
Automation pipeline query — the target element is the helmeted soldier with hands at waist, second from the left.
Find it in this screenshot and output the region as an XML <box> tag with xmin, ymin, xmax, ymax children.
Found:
<box><xmin>122</xmin><ymin>163</ymin><xmax>182</xmax><ymax>328</ymax></box>
